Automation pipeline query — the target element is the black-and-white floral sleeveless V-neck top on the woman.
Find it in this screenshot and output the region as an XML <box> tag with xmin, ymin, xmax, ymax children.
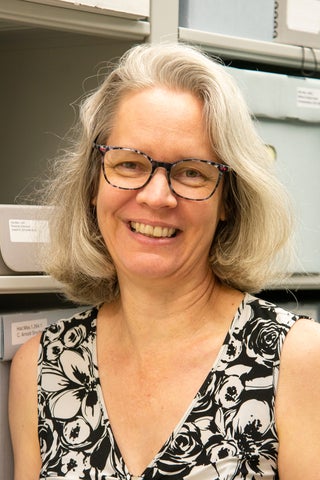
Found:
<box><xmin>38</xmin><ymin>294</ymin><xmax>298</xmax><ymax>480</ymax></box>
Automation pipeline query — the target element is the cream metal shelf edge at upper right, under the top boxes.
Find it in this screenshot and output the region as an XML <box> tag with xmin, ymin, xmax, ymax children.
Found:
<box><xmin>179</xmin><ymin>27</ymin><xmax>320</xmax><ymax>71</ymax></box>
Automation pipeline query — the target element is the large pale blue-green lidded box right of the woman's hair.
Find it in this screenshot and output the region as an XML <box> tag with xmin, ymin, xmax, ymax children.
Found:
<box><xmin>228</xmin><ymin>68</ymin><xmax>320</xmax><ymax>274</ymax></box>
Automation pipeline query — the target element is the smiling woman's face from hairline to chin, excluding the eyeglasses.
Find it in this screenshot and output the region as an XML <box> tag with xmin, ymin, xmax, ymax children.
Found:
<box><xmin>93</xmin><ymin>87</ymin><xmax>225</xmax><ymax>281</ymax></box>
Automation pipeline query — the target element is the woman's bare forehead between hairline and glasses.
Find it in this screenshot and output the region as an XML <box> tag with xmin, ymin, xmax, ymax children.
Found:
<box><xmin>108</xmin><ymin>87</ymin><xmax>213</xmax><ymax>158</ymax></box>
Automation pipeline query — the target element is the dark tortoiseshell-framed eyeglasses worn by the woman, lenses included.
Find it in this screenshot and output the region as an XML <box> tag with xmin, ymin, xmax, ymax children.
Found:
<box><xmin>93</xmin><ymin>142</ymin><xmax>231</xmax><ymax>201</ymax></box>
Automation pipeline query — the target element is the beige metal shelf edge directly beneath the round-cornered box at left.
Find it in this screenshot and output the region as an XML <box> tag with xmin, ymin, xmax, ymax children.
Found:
<box><xmin>0</xmin><ymin>275</ymin><xmax>62</xmax><ymax>299</ymax></box>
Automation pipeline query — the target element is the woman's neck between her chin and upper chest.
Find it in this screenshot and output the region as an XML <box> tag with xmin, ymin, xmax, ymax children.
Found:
<box><xmin>101</xmin><ymin>272</ymin><xmax>221</xmax><ymax>348</ymax></box>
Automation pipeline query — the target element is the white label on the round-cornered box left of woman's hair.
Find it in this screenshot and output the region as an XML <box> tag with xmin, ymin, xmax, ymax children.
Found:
<box><xmin>9</xmin><ymin>219</ymin><xmax>50</xmax><ymax>243</ymax></box>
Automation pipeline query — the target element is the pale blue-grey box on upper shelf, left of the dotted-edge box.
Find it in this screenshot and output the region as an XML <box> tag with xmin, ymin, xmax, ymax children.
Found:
<box><xmin>179</xmin><ymin>0</ymin><xmax>275</xmax><ymax>41</ymax></box>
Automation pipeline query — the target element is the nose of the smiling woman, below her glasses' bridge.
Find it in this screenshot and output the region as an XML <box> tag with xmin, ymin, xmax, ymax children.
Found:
<box><xmin>136</xmin><ymin>168</ymin><xmax>177</xmax><ymax>209</ymax></box>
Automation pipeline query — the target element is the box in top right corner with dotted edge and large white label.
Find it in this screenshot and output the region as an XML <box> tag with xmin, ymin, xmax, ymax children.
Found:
<box><xmin>274</xmin><ymin>0</ymin><xmax>320</xmax><ymax>49</ymax></box>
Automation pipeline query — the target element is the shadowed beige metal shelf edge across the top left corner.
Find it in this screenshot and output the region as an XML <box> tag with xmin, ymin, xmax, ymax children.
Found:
<box><xmin>0</xmin><ymin>0</ymin><xmax>150</xmax><ymax>40</ymax></box>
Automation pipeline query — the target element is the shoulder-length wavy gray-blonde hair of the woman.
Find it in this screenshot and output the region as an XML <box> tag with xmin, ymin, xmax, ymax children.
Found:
<box><xmin>45</xmin><ymin>44</ymin><xmax>292</xmax><ymax>304</ymax></box>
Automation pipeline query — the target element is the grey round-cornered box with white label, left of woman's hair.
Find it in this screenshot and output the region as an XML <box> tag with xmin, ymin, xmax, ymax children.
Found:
<box><xmin>0</xmin><ymin>205</ymin><xmax>51</xmax><ymax>275</ymax></box>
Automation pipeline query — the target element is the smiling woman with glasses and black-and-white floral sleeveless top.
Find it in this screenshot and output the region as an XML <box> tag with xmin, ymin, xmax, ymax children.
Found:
<box><xmin>10</xmin><ymin>45</ymin><xmax>320</xmax><ymax>480</ymax></box>
